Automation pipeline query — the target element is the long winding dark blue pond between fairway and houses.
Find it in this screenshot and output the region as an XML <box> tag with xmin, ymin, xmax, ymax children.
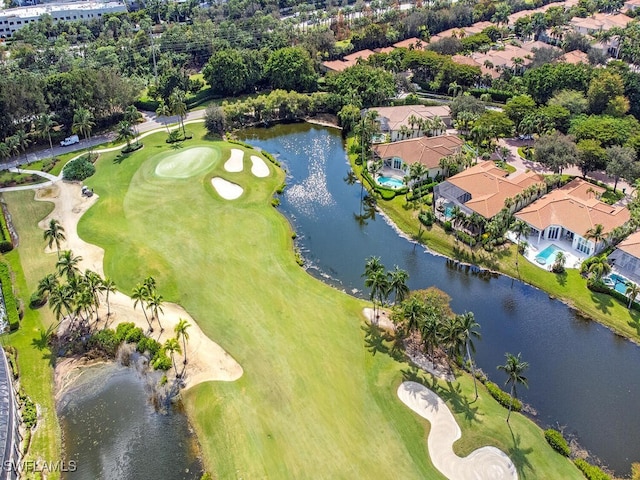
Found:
<box><xmin>241</xmin><ymin>124</ymin><xmax>640</xmax><ymax>475</ymax></box>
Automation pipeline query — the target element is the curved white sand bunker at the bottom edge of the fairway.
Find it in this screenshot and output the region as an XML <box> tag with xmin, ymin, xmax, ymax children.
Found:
<box><xmin>398</xmin><ymin>382</ymin><xmax>518</xmax><ymax>480</ymax></box>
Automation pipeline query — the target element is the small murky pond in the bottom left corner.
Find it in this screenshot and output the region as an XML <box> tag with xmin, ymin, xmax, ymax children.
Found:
<box><xmin>58</xmin><ymin>364</ymin><xmax>203</xmax><ymax>480</ymax></box>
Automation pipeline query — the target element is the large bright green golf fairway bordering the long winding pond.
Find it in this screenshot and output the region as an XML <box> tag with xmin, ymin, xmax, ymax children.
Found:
<box><xmin>52</xmin><ymin>126</ymin><xmax>581</xmax><ymax>479</ymax></box>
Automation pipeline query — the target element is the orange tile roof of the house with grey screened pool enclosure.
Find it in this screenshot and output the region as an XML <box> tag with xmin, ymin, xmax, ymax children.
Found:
<box><xmin>447</xmin><ymin>161</ymin><xmax>543</xmax><ymax>218</ymax></box>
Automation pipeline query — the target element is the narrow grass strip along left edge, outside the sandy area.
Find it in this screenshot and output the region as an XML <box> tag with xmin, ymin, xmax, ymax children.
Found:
<box><xmin>3</xmin><ymin>191</ymin><xmax>61</xmax><ymax>478</ymax></box>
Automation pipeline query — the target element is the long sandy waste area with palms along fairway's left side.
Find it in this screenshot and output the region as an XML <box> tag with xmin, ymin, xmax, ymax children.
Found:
<box><xmin>36</xmin><ymin>181</ymin><xmax>243</xmax><ymax>388</ymax></box>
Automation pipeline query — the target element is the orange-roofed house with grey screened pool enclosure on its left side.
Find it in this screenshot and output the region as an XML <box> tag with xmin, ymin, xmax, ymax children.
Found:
<box><xmin>433</xmin><ymin>161</ymin><xmax>544</xmax><ymax>221</ymax></box>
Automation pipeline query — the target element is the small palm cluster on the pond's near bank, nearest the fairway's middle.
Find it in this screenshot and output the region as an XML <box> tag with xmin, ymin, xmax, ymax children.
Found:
<box><xmin>362</xmin><ymin>257</ymin><xmax>409</xmax><ymax>318</ymax></box>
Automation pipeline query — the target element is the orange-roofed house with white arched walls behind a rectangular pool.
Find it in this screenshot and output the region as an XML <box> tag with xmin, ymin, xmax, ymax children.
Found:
<box><xmin>515</xmin><ymin>178</ymin><xmax>631</xmax><ymax>258</ymax></box>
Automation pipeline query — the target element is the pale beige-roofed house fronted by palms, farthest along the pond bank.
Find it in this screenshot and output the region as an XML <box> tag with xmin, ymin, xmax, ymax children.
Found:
<box><xmin>373</xmin><ymin>105</ymin><xmax>451</xmax><ymax>142</ymax></box>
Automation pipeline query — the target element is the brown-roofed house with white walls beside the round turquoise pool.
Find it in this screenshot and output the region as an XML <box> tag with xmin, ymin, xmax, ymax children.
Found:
<box><xmin>373</xmin><ymin>135</ymin><xmax>464</xmax><ymax>178</ymax></box>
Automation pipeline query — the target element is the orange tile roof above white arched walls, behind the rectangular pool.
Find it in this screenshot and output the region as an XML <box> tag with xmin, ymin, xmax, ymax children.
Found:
<box><xmin>516</xmin><ymin>178</ymin><xmax>631</xmax><ymax>236</ymax></box>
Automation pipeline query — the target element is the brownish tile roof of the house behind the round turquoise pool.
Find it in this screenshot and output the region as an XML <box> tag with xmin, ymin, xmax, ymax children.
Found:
<box><xmin>374</xmin><ymin>135</ymin><xmax>464</xmax><ymax>168</ymax></box>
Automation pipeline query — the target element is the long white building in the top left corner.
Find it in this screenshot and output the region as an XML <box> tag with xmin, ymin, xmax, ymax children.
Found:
<box><xmin>0</xmin><ymin>1</ymin><xmax>127</xmax><ymax>38</ymax></box>
